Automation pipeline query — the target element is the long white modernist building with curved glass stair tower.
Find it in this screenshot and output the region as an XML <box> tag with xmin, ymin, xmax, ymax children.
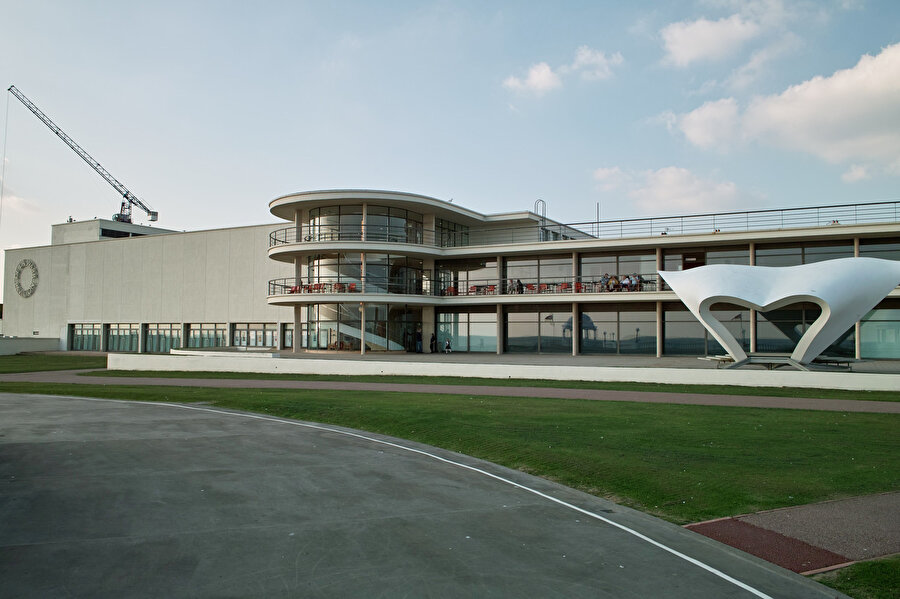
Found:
<box><xmin>4</xmin><ymin>190</ymin><xmax>900</xmax><ymax>359</ymax></box>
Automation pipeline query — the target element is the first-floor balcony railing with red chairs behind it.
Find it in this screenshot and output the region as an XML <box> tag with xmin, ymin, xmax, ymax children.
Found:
<box><xmin>269</xmin><ymin>275</ymin><xmax>658</xmax><ymax>297</ymax></box>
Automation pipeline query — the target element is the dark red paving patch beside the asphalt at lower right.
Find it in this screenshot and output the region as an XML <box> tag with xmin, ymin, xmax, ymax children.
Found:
<box><xmin>685</xmin><ymin>518</ymin><xmax>851</xmax><ymax>573</ymax></box>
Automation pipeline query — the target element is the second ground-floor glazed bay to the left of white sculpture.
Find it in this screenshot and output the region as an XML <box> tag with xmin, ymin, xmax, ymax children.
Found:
<box><xmin>506</xmin><ymin>305</ymin><xmax>572</xmax><ymax>353</ymax></box>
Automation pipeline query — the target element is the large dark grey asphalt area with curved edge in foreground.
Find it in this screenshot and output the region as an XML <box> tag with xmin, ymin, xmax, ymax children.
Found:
<box><xmin>0</xmin><ymin>393</ymin><xmax>840</xmax><ymax>599</ymax></box>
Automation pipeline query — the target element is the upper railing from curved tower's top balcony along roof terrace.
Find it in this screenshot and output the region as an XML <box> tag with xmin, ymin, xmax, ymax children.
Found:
<box><xmin>269</xmin><ymin>200</ymin><xmax>900</xmax><ymax>247</ymax></box>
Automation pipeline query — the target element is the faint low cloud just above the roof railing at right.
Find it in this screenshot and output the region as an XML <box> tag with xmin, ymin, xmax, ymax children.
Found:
<box><xmin>628</xmin><ymin>166</ymin><xmax>741</xmax><ymax>214</ymax></box>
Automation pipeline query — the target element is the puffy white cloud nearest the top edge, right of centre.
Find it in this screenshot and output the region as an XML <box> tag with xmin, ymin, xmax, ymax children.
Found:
<box><xmin>659</xmin><ymin>14</ymin><xmax>761</xmax><ymax>67</ymax></box>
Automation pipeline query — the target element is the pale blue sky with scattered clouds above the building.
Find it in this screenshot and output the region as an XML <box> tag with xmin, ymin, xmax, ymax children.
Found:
<box><xmin>0</xmin><ymin>0</ymin><xmax>900</xmax><ymax>298</ymax></box>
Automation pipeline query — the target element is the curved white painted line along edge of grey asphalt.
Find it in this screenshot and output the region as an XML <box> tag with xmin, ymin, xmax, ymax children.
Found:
<box><xmin>44</xmin><ymin>395</ymin><xmax>773</xmax><ymax>599</ymax></box>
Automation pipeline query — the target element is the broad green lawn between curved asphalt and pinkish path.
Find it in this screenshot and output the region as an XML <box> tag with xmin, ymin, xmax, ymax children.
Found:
<box><xmin>0</xmin><ymin>383</ymin><xmax>900</xmax><ymax>523</ymax></box>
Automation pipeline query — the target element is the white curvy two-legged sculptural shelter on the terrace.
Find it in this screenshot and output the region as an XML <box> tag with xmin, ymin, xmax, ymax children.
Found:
<box><xmin>659</xmin><ymin>258</ymin><xmax>900</xmax><ymax>365</ymax></box>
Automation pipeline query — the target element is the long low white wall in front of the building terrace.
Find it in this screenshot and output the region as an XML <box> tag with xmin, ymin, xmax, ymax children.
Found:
<box><xmin>108</xmin><ymin>354</ymin><xmax>900</xmax><ymax>391</ymax></box>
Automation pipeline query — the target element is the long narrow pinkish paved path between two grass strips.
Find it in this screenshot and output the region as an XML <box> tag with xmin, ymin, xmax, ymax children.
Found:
<box><xmin>0</xmin><ymin>370</ymin><xmax>900</xmax><ymax>414</ymax></box>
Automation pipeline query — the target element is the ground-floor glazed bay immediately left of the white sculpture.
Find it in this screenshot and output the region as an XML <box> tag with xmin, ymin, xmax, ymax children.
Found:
<box><xmin>580</xmin><ymin>304</ymin><xmax>656</xmax><ymax>355</ymax></box>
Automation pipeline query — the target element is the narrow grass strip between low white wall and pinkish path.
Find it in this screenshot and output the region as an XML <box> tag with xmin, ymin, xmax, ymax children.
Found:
<box><xmin>84</xmin><ymin>370</ymin><xmax>900</xmax><ymax>401</ymax></box>
